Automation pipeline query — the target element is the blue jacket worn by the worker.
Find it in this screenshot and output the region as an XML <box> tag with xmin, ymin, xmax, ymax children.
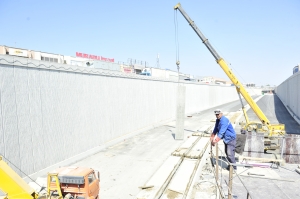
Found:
<box><xmin>213</xmin><ymin>116</ymin><xmax>236</xmax><ymax>144</ymax></box>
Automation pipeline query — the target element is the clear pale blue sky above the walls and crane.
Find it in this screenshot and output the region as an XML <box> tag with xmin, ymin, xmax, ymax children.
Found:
<box><xmin>0</xmin><ymin>0</ymin><xmax>300</xmax><ymax>85</ymax></box>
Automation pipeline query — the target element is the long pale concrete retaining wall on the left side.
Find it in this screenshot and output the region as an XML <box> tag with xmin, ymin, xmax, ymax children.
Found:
<box><xmin>0</xmin><ymin>55</ymin><xmax>261</xmax><ymax>174</ymax></box>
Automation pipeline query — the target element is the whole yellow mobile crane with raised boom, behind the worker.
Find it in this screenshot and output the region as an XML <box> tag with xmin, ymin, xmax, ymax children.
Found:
<box><xmin>174</xmin><ymin>3</ymin><xmax>285</xmax><ymax>140</ymax></box>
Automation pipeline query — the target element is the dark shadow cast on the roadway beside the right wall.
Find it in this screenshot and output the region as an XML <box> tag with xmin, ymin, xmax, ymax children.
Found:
<box><xmin>272</xmin><ymin>95</ymin><xmax>300</xmax><ymax>135</ymax></box>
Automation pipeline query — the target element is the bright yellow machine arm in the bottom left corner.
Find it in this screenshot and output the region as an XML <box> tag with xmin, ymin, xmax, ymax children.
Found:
<box><xmin>0</xmin><ymin>156</ymin><xmax>38</xmax><ymax>199</ymax></box>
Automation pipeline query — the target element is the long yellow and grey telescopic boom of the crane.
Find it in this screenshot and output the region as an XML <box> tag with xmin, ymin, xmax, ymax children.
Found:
<box><xmin>174</xmin><ymin>3</ymin><xmax>284</xmax><ymax>136</ymax></box>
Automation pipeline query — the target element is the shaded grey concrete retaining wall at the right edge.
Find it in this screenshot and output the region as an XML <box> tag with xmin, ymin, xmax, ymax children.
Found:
<box><xmin>275</xmin><ymin>72</ymin><xmax>300</xmax><ymax>124</ymax></box>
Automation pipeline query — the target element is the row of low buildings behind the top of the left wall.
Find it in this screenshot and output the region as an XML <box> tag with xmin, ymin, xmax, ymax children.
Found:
<box><xmin>0</xmin><ymin>45</ymin><xmax>246</xmax><ymax>85</ymax></box>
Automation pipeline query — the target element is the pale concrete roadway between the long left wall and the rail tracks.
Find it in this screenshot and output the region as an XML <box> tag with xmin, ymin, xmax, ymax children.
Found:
<box><xmin>65</xmin><ymin>97</ymin><xmax>258</xmax><ymax>199</ymax></box>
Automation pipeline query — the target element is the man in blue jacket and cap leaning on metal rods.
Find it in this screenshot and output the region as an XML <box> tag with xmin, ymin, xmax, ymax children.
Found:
<box><xmin>210</xmin><ymin>109</ymin><xmax>236</xmax><ymax>170</ymax></box>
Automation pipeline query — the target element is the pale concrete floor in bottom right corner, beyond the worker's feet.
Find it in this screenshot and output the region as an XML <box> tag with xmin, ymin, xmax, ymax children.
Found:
<box><xmin>219</xmin><ymin>146</ymin><xmax>300</xmax><ymax>199</ymax></box>
